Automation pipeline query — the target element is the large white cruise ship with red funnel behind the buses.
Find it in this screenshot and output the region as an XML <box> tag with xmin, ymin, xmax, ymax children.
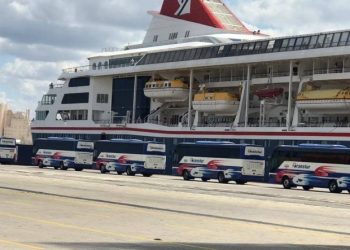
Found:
<box><xmin>31</xmin><ymin>0</ymin><xmax>350</xmax><ymax>173</ymax></box>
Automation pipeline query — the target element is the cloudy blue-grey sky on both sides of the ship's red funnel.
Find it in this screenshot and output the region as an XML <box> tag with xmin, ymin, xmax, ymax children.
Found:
<box><xmin>0</xmin><ymin>0</ymin><xmax>350</xmax><ymax>116</ymax></box>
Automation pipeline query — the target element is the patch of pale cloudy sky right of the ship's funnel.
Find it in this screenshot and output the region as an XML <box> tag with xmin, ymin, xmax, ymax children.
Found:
<box><xmin>231</xmin><ymin>0</ymin><xmax>350</xmax><ymax>36</ymax></box>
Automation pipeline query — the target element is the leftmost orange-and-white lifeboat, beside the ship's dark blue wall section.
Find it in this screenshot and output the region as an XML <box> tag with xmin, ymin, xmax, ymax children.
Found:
<box><xmin>143</xmin><ymin>80</ymin><xmax>189</xmax><ymax>102</ymax></box>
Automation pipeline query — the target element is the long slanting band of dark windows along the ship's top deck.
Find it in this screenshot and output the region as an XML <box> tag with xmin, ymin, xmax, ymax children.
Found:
<box><xmin>138</xmin><ymin>31</ymin><xmax>350</xmax><ymax>65</ymax></box>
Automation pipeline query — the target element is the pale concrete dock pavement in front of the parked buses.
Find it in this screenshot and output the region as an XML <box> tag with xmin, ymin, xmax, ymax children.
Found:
<box><xmin>0</xmin><ymin>165</ymin><xmax>350</xmax><ymax>250</ymax></box>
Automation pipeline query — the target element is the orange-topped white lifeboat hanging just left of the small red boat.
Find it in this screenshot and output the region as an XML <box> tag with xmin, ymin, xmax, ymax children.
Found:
<box><xmin>192</xmin><ymin>92</ymin><xmax>239</xmax><ymax>114</ymax></box>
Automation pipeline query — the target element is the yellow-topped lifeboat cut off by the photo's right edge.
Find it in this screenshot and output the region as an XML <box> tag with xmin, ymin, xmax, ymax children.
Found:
<box><xmin>296</xmin><ymin>89</ymin><xmax>350</xmax><ymax>114</ymax></box>
